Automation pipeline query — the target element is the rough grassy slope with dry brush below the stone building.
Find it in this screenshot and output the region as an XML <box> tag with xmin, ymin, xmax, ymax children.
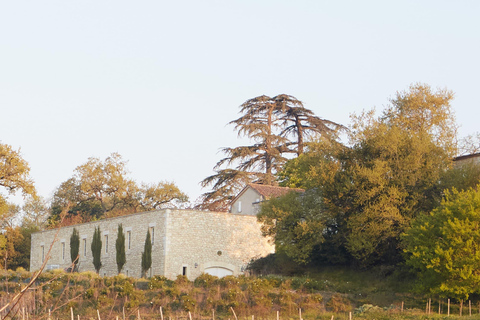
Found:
<box><xmin>0</xmin><ymin>267</ymin><xmax>480</xmax><ymax>320</ymax></box>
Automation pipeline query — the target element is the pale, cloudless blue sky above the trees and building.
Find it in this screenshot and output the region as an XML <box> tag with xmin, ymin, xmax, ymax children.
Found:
<box><xmin>0</xmin><ymin>0</ymin><xmax>480</xmax><ymax>204</ymax></box>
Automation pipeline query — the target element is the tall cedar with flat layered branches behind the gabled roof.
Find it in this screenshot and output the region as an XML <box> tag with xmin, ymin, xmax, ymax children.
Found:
<box><xmin>198</xmin><ymin>94</ymin><xmax>344</xmax><ymax>211</ymax></box>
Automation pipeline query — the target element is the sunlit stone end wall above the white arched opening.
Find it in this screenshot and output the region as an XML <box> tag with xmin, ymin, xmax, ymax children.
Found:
<box><xmin>165</xmin><ymin>210</ymin><xmax>274</xmax><ymax>279</ymax></box>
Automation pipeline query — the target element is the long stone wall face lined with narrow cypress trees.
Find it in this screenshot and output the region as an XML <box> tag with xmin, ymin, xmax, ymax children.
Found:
<box><xmin>30</xmin><ymin>210</ymin><xmax>165</xmax><ymax>277</ymax></box>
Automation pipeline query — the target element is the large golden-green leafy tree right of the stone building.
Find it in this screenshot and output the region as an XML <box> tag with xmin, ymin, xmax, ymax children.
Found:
<box><xmin>276</xmin><ymin>84</ymin><xmax>456</xmax><ymax>267</ymax></box>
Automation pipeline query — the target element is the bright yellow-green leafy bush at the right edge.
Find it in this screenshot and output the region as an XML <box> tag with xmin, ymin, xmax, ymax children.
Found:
<box><xmin>403</xmin><ymin>187</ymin><xmax>480</xmax><ymax>299</ymax></box>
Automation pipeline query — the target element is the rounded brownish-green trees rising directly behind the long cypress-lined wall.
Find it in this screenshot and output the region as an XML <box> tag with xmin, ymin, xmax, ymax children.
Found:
<box><xmin>49</xmin><ymin>153</ymin><xmax>188</xmax><ymax>225</ymax></box>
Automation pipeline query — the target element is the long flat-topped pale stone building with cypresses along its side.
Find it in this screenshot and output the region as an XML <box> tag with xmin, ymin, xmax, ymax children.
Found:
<box><xmin>30</xmin><ymin>209</ymin><xmax>274</xmax><ymax>279</ymax></box>
